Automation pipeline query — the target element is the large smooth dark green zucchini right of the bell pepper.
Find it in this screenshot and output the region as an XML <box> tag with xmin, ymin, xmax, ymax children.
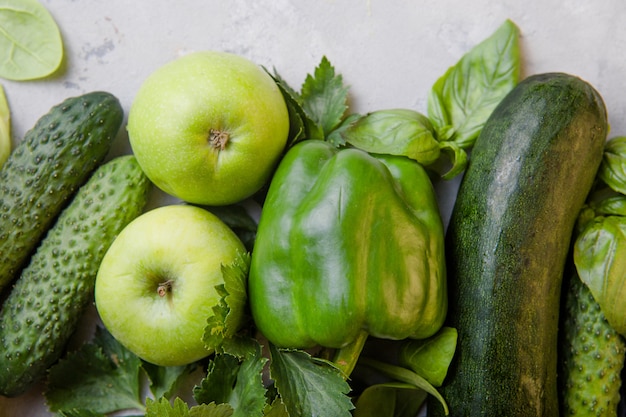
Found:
<box><xmin>429</xmin><ymin>73</ymin><xmax>608</xmax><ymax>417</ymax></box>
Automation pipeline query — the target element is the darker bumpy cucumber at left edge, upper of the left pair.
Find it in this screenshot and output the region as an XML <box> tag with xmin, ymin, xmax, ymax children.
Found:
<box><xmin>0</xmin><ymin>92</ymin><xmax>124</xmax><ymax>291</ymax></box>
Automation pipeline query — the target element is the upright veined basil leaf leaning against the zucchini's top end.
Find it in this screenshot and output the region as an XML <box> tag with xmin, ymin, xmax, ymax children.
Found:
<box><xmin>428</xmin><ymin>20</ymin><xmax>521</xmax><ymax>149</ymax></box>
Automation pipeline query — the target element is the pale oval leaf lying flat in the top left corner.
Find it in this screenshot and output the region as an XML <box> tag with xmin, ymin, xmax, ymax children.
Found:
<box><xmin>0</xmin><ymin>0</ymin><xmax>63</xmax><ymax>81</ymax></box>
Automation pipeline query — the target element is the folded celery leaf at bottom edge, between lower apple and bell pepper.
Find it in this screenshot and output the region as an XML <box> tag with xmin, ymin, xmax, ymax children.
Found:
<box><xmin>193</xmin><ymin>344</ymin><xmax>267</xmax><ymax>417</ymax></box>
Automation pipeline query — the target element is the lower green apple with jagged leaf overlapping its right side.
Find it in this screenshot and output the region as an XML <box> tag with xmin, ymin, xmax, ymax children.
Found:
<box><xmin>95</xmin><ymin>204</ymin><xmax>245</xmax><ymax>366</ymax></box>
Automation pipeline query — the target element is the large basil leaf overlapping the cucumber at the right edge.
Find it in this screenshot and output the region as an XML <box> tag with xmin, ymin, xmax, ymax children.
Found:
<box><xmin>574</xmin><ymin>216</ymin><xmax>626</xmax><ymax>336</ymax></box>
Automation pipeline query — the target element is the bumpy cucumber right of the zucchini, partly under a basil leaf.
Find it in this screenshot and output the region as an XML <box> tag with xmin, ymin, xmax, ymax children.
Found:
<box><xmin>559</xmin><ymin>273</ymin><xmax>626</xmax><ymax>417</ymax></box>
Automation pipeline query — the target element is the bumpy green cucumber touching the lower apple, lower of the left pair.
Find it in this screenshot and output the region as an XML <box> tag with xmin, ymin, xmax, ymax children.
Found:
<box><xmin>0</xmin><ymin>156</ymin><xmax>150</xmax><ymax>396</ymax></box>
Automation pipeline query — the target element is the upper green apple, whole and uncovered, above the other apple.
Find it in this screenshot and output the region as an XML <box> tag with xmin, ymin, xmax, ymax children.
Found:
<box><xmin>127</xmin><ymin>51</ymin><xmax>289</xmax><ymax>206</ymax></box>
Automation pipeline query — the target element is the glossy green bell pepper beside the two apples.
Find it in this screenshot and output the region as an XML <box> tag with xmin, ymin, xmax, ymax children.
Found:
<box><xmin>249</xmin><ymin>140</ymin><xmax>447</xmax><ymax>349</ymax></box>
